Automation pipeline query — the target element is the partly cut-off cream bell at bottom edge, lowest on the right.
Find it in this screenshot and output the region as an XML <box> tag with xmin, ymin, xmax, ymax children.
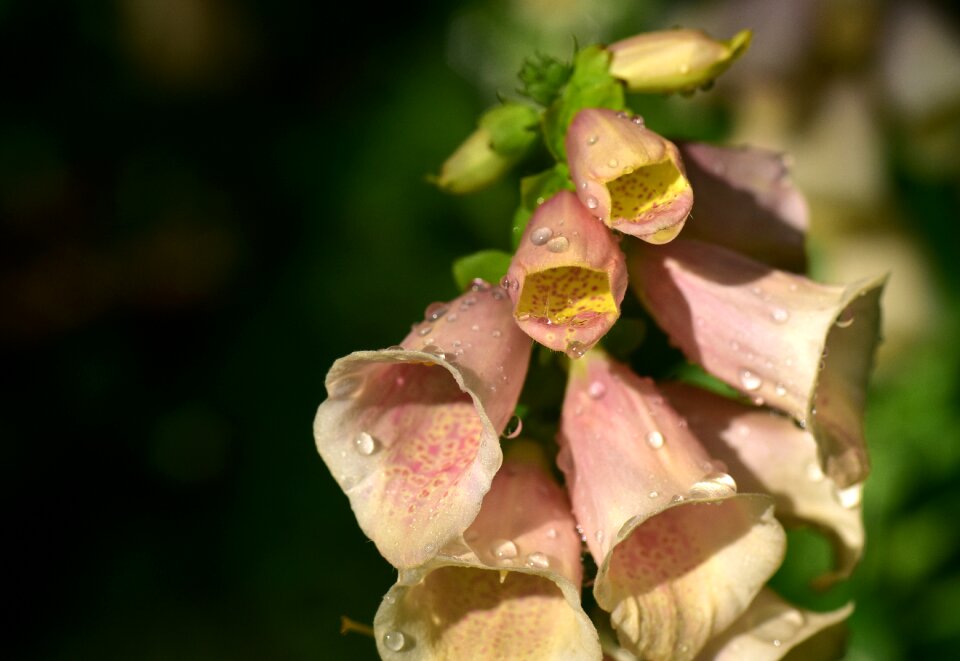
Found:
<box><xmin>698</xmin><ymin>589</ymin><xmax>853</xmax><ymax>661</ymax></box>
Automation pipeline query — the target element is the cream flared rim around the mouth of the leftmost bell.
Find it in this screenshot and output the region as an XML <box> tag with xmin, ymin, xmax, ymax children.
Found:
<box><xmin>313</xmin><ymin>349</ymin><xmax>503</xmax><ymax>567</ymax></box>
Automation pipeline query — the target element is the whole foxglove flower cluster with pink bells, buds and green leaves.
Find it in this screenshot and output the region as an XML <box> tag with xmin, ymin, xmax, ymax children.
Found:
<box><xmin>314</xmin><ymin>25</ymin><xmax>883</xmax><ymax>659</ymax></box>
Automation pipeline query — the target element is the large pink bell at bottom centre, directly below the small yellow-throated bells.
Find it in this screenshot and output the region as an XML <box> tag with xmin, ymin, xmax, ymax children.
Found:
<box><xmin>558</xmin><ymin>350</ymin><xmax>786</xmax><ymax>660</ymax></box>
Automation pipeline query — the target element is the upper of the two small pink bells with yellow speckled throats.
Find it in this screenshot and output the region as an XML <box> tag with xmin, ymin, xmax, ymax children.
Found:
<box><xmin>566</xmin><ymin>108</ymin><xmax>693</xmax><ymax>243</ymax></box>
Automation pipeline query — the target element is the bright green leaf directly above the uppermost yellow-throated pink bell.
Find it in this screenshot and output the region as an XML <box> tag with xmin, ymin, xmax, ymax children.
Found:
<box><xmin>543</xmin><ymin>46</ymin><xmax>626</xmax><ymax>161</ymax></box>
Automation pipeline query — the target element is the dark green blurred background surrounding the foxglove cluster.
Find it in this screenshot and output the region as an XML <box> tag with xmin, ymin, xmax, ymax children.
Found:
<box><xmin>0</xmin><ymin>0</ymin><xmax>960</xmax><ymax>659</ymax></box>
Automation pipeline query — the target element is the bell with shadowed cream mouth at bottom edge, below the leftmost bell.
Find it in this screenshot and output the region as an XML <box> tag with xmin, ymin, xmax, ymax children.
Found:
<box><xmin>374</xmin><ymin>441</ymin><xmax>601</xmax><ymax>661</ymax></box>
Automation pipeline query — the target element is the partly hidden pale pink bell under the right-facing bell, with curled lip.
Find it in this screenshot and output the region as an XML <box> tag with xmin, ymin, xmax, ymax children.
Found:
<box><xmin>660</xmin><ymin>383</ymin><xmax>864</xmax><ymax>587</ymax></box>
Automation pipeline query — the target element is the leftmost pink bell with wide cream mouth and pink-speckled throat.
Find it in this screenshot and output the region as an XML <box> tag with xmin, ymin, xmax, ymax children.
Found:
<box><xmin>313</xmin><ymin>282</ymin><xmax>531</xmax><ymax>567</ymax></box>
